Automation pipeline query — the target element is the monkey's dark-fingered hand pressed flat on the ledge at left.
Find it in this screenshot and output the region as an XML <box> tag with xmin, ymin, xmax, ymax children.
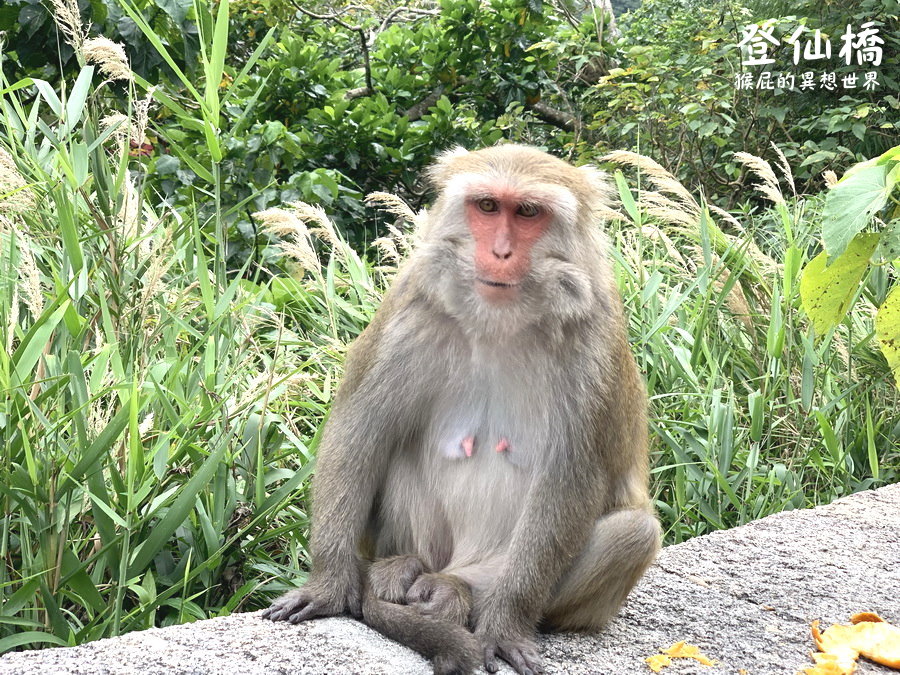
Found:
<box><xmin>262</xmin><ymin>568</ymin><xmax>362</xmax><ymax>623</ymax></box>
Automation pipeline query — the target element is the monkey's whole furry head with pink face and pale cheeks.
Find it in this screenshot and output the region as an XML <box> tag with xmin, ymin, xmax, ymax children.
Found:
<box><xmin>420</xmin><ymin>145</ymin><xmax>604</xmax><ymax>333</ymax></box>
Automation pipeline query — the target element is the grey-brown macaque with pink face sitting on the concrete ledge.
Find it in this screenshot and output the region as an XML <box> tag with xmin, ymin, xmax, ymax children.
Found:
<box><xmin>263</xmin><ymin>145</ymin><xmax>660</xmax><ymax>675</ymax></box>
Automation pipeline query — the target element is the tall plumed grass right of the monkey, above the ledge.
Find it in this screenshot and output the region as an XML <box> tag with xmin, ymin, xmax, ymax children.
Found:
<box><xmin>606</xmin><ymin>148</ymin><xmax>900</xmax><ymax>542</ymax></box>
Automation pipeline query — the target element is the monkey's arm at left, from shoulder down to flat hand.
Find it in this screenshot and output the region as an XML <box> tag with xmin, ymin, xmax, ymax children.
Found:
<box><xmin>263</xmin><ymin>298</ymin><xmax>426</xmax><ymax>623</ymax></box>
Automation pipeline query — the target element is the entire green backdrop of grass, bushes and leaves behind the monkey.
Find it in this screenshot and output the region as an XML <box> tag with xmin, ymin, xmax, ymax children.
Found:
<box><xmin>0</xmin><ymin>0</ymin><xmax>900</xmax><ymax>652</ymax></box>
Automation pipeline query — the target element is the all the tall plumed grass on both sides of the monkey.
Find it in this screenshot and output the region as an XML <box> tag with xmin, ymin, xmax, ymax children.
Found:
<box><xmin>0</xmin><ymin>0</ymin><xmax>900</xmax><ymax>652</ymax></box>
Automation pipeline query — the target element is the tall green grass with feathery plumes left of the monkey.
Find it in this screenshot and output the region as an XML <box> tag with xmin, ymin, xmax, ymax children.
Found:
<box><xmin>0</xmin><ymin>2</ymin><xmax>380</xmax><ymax>652</ymax></box>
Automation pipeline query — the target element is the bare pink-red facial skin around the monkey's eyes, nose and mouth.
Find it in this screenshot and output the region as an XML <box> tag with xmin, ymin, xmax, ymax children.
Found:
<box><xmin>466</xmin><ymin>189</ymin><xmax>551</xmax><ymax>303</ymax></box>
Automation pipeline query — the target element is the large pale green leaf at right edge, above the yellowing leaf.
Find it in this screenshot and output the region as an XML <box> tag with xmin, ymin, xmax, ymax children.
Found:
<box><xmin>822</xmin><ymin>164</ymin><xmax>894</xmax><ymax>257</ymax></box>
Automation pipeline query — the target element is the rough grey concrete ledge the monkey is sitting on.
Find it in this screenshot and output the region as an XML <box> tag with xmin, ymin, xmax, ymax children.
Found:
<box><xmin>0</xmin><ymin>484</ymin><xmax>900</xmax><ymax>675</ymax></box>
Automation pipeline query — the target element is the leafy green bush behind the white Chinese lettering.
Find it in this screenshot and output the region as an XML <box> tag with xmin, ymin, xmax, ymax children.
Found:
<box><xmin>586</xmin><ymin>0</ymin><xmax>900</xmax><ymax>201</ymax></box>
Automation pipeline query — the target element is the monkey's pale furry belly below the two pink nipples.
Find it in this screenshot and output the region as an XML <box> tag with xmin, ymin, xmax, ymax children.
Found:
<box><xmin>374</xmin><ymin>433</ymin><xmax>531</xmax><ymax>570</ymax></box>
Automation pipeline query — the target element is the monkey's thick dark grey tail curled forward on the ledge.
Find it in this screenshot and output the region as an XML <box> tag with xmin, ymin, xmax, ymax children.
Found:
<box><xmin>362</xmin><ymin>583</ymin><xmax>481</xmax><ymax>675</ymax></box>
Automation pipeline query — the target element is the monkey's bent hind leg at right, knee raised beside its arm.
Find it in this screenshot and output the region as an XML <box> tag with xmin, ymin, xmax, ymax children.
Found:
<box><xmin>541</xmin><ymin>509</ymin><xmax>660</xmax><ymax>630</ymax></box>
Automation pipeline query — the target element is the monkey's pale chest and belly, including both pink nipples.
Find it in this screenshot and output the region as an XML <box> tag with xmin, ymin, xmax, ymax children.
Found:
<box><xmin>379</xmin><ymin>388</ymin><xmax>545</xmax><ymax>569</ymax></box>
